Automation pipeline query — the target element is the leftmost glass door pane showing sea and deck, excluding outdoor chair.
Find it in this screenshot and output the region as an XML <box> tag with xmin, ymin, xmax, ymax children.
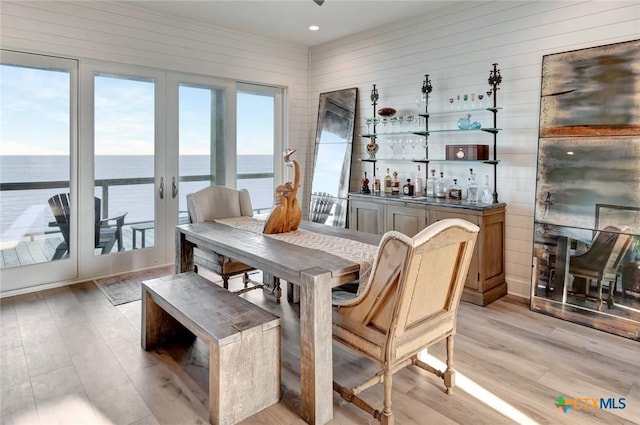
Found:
<box><xmin>0</xmin><ymin>64</ymin><xmax>71</xmax><ymax>268</ymax></box>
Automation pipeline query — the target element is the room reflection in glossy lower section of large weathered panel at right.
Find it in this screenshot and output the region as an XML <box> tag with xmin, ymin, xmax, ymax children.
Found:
<box><xmin>531</xmin><ymin>210</ymin><xmax>640</xmax><ymax>340</ymax></box>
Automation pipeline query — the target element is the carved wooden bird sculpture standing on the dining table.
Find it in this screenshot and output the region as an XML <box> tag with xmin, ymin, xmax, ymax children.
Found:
<box><xmin>262</xmin><ymin>149</ymin><xmax>302</xmax><ymax>235</ymax></box>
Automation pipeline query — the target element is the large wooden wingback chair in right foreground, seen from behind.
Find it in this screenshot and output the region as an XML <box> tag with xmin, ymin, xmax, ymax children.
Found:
<box><xmin>333</xmin><ymin>219</ymin><xmax>479</xmax><ymax>425</ymax></box>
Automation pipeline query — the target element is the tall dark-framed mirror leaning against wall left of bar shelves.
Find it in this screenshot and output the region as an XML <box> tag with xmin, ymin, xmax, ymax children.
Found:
<box><xmin>309</xmin><ymin>88</ymin><xmax>358</xmax><ymax>227</ymax></box>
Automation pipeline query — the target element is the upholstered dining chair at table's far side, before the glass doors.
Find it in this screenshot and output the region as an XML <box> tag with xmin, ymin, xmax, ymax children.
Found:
<box><xmin>187</xmin><ymin>186</ymin><xmax>280</xmax><ymax>300</ymax></box>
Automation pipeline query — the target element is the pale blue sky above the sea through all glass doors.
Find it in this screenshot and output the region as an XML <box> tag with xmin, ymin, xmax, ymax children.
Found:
<box><xmin>0</xmin><ymin>65</ymin><xmax>273</xmax><ymax>155</ymax></box>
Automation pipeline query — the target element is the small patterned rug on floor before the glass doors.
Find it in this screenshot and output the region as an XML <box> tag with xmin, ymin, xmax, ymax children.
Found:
<box><xmin>93</xmin><ymin>266</ymin><xmax>174</xmax><ymax>305</ymax></box>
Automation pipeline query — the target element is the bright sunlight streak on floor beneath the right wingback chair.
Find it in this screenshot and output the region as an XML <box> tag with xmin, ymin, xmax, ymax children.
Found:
<box><xmin>418</xmin><ymin>350</ymin><xmax>539</xmax><ymax>425</ymax></box>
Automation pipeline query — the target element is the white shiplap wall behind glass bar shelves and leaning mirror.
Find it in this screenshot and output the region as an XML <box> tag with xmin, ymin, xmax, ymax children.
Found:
<box><xmin>309</xmin><ymin>1</ymin><xmax>640</xmax><ymax>298</ymax></box>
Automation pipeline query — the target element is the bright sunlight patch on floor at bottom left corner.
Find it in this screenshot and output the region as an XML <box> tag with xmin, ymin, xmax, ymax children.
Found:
<box><xmin>10</xmin><ymin>396</ymin><xmax>114</xmax><ymax>425</ymax></box>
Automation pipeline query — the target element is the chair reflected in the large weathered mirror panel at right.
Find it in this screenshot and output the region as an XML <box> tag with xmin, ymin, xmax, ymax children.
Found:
<box><xmin>569</xmin><ymin>226</ymin><xmax>632</xmax><ymax>310</ymax></box>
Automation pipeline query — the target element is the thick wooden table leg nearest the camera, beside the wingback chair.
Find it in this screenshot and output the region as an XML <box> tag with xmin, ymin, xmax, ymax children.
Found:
<box><xmin>300</xmin><ymin>268</ymin><xmax>333</xmax><ymax>425</ymax></box>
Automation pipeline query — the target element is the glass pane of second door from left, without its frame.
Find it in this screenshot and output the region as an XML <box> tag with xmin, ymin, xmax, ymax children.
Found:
<box><xmin>93</xmin><ymin>74</ymin><xmax>155</xmax><ymax>255</ymax></box>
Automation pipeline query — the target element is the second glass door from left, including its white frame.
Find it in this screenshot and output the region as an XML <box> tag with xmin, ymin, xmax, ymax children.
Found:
<box><xmin>78</xmin><ymin>63</ymin><xmax>168</xmax><ymax>276</ymax></box>
